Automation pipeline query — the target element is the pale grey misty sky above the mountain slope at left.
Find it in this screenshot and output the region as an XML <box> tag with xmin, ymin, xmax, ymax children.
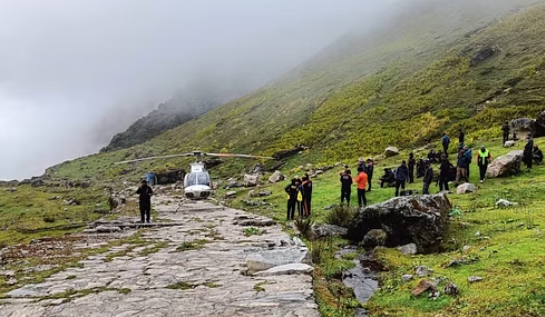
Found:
<box><xmin>0</xmin><ymin>0</ymin><xmax>396</xmax><ymax>179</ymax></box>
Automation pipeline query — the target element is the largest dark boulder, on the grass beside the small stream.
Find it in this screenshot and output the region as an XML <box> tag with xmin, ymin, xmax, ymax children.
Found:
<box><xmin>348</xmin><ymin>194</ymin><xmax>452</xmax><ymax>252</ymax></box>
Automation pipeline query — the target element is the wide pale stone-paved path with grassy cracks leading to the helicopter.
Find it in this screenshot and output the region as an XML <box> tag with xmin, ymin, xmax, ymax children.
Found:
<box><xmin>0</xmin><ymin>197</ymin><xmax>319</xmax><ymax>317</ymax></box>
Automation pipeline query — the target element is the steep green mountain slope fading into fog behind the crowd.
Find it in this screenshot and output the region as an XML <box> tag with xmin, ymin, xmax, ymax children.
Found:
<box><xmin>49</xmin><ymin>0</ymin><xmax>545</xmax><ymax>179</ymax></box>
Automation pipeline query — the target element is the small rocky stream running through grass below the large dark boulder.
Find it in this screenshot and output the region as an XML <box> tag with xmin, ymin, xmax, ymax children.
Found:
<box><xmin>337</xmin><ymin>247</ymin><xmax>380</xmax><ymax>317</ymax></box>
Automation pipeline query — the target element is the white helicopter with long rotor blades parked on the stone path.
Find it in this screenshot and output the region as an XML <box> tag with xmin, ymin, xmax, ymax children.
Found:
<box><xmin>116</xmin><ymin>151</ymin><xmax>274</xmax><ymax>200</ymax></box>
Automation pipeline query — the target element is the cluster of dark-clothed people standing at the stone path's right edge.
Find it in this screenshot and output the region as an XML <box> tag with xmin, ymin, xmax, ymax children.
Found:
<box><xmin>284</xmin><ymin>174</ymin><xmax>312</xmax><ymax>220</ymax></box>
